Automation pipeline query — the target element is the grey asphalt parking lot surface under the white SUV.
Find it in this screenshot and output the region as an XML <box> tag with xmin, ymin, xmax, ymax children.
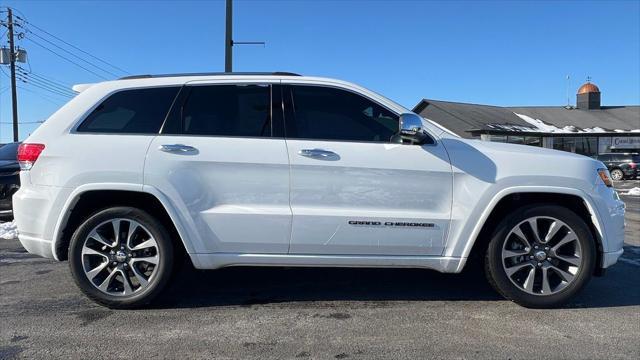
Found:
<box><xmin>0</xmin><ymin>181</ymin><xmax>640</xmax><ymax>359</ymax></box>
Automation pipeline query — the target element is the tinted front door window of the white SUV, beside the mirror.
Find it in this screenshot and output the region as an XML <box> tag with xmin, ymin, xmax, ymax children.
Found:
<box><xmin>285</xmin><ymin>86</ymin><xmax>398</xmax><ymax>142</ymax></box>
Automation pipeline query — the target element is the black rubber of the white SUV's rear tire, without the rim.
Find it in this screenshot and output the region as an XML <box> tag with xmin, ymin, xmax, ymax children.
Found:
<box><xmin>69</xmin><ymin>207</ymin><xmax>173</xmax><ymax>308</ymax></box>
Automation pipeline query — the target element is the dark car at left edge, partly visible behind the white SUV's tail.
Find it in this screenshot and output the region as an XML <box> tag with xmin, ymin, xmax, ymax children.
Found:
<box><xmin>0</xmin><ymin>142</ymin><xmax>20</xmax><ymax>219</ymax></box>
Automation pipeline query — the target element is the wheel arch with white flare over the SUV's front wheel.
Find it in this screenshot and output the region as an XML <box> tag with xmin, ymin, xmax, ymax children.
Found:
<box><xmin>461</xmin><ymin>188</ymin><xmax>603</xmax><ymax>275</ymax></box>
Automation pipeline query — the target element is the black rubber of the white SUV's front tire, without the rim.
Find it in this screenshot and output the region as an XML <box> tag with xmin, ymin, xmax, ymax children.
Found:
<box><xmin>486</xmin><ymin>205</ymin><xmax>596</xmax><ymax>308</ymax></box>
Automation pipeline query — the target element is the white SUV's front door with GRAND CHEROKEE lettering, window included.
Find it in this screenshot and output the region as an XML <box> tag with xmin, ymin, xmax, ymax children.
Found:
<box><xmin>283</xmin><ymin>85</ymin><xmax>452</xmax><ymax>255</ymax></box>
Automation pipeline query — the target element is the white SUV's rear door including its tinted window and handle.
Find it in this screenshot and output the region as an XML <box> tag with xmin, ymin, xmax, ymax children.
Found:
<box><xmin>144</xmin><ymin>81</ymin><xmax>291</xmax><ymax>254</ymax></box>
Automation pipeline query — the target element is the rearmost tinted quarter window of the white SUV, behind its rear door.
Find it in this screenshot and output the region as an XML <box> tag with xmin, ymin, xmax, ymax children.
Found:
<box><xmin>78</xmin><ymin>87</ymin><xmax>179</xmax><ymax>134</ymax></box>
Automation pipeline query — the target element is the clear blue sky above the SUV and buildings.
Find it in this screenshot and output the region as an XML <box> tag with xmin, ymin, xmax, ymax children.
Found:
<box><xmin>0</xmin><ymin>0</ymin><xmax>640</xmax><ymax>142</ymax></box>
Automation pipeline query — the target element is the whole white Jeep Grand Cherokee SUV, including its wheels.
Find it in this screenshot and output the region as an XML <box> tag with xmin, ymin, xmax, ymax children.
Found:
<box><xmin>13</xmin><ymin>73</ymin><xmax>624</xmax><ymax>308</ymax></box>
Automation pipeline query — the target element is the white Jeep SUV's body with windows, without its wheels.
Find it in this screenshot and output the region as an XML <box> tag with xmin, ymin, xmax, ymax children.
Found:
<box><xmin>13</xmin><ymin>73</ymin><xmax>624</xmax><ymax>305</ymax></box>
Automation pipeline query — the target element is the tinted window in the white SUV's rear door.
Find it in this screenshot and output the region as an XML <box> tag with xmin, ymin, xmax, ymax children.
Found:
<box><xmin>179</xmin><ymin>85</ymin><xmax>271</xmax><ymax>137</ymax></box>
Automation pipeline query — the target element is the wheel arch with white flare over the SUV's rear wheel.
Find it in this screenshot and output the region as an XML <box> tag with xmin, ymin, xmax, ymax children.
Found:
<box><xmin>52</xmin><ymin>185</ymin><xmax>193</xmax><ymax>261</ymax></box>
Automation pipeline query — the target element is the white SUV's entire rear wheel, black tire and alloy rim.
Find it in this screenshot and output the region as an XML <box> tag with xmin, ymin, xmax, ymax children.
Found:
<box><xmin>69</xmin><ymin>207</ymin><xmax>174</xmax><ymax>309</ymax></box>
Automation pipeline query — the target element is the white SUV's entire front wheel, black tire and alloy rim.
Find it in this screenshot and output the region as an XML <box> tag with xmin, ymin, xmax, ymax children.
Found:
<box><xmin>485</xmin><ymin>205</ymin><xmax>596</xmax><ymax>308</ymax></box>
